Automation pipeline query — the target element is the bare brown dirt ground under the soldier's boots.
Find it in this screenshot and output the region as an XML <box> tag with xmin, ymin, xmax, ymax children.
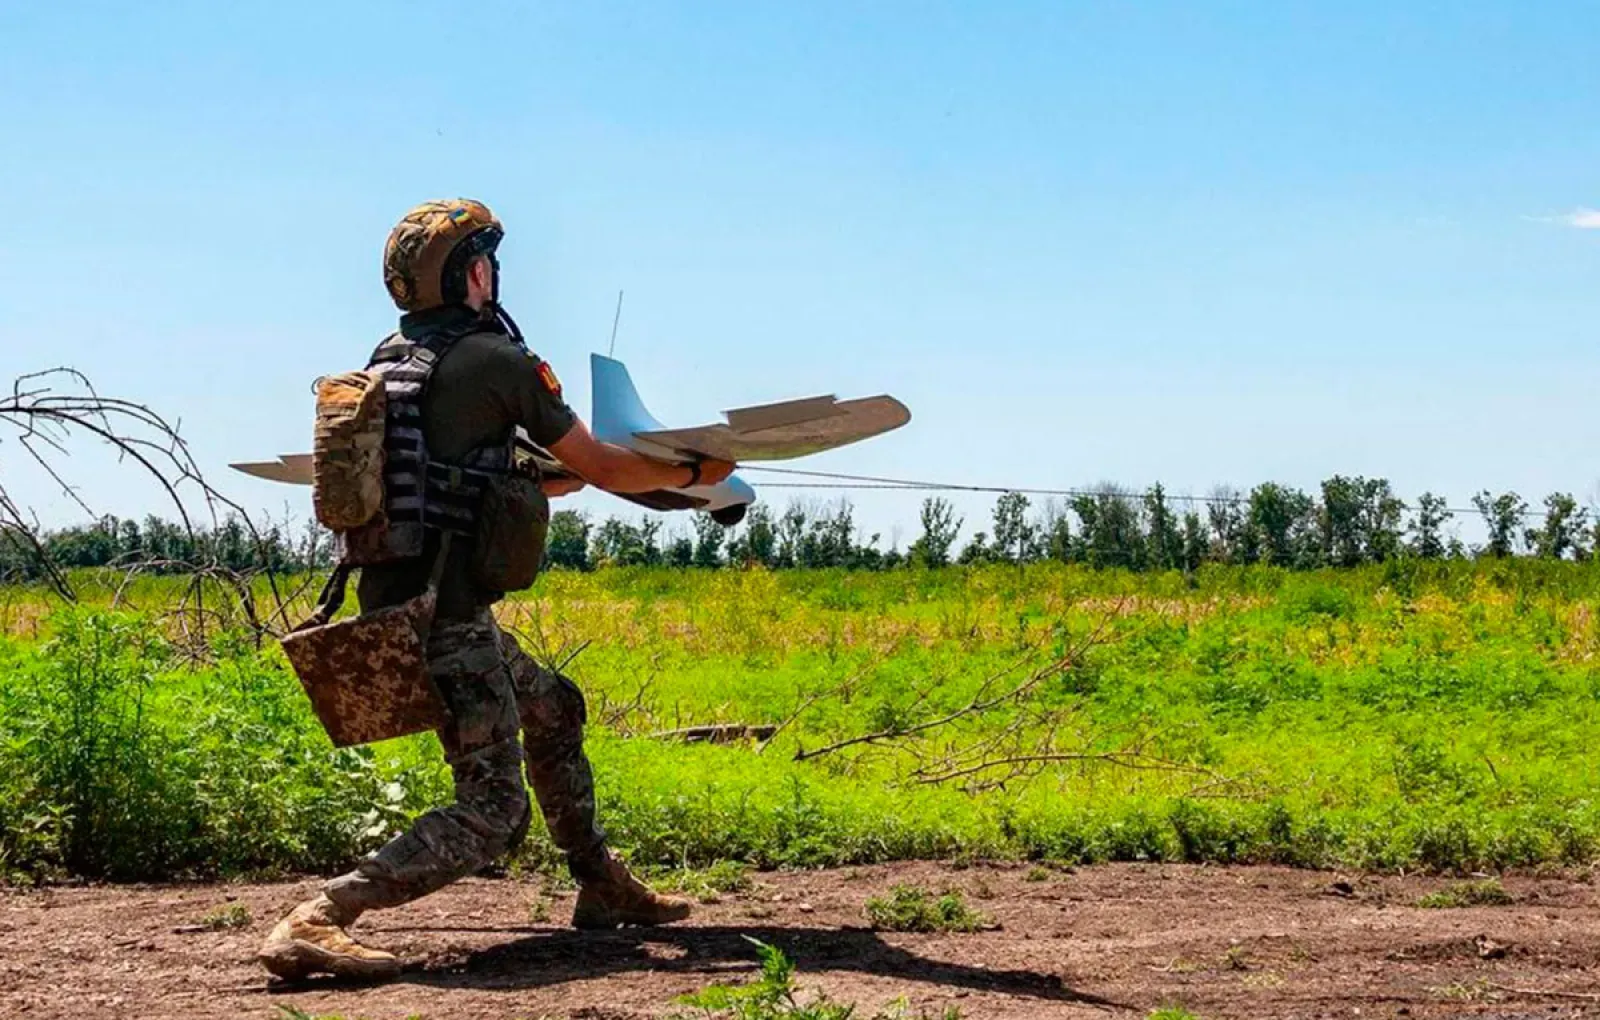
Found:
<box><xmin>0</xmin><ymin>863</ymin><xmax>1600</xmax><ymax>1020</ymax></box>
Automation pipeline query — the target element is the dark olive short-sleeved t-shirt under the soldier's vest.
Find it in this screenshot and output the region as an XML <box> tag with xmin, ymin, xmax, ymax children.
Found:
<box><xmin>357</xmin><ymin>309</ymin><xmax>578</xmax><ymax>620</ymax></box>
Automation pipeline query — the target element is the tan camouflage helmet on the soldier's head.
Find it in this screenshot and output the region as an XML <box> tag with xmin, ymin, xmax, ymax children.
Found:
<box><xmin>384</xmin><ymin>198</ymin><xmax>504</xmax><ymax>312</ymax></box>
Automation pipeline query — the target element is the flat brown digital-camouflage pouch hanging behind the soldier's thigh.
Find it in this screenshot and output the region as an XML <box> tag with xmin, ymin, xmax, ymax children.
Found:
<box><xmin>282</xmin><ymin>534</ymin><xmax>450</xmax><ymax>747</ymax></box>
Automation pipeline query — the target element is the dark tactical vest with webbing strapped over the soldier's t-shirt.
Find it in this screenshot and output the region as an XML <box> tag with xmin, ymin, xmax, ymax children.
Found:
<box><xmin>341</xmin><ymin>323</ymin><xmax>512</xmax><ymax>566</ymax></box>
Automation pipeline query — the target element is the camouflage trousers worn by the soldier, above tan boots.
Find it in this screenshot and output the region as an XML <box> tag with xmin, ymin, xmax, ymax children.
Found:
<box><xmin>323</xmin><ymin>609</ymin><xmax>606</xmax><ymax>911</ymax></box>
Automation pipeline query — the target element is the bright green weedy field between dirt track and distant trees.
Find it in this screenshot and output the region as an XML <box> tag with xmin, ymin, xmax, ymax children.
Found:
<box><xmin>0</xmin><ymin>561</ymin><xmax>1600</xmax><ymax>879</ymax></box>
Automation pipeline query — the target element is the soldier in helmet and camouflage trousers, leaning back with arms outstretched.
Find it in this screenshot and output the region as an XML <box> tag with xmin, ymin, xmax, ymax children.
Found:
<box><xmin>259</xmin><ymin>200</ymin><xmax>733</xmax><ymax>978</ymax></box>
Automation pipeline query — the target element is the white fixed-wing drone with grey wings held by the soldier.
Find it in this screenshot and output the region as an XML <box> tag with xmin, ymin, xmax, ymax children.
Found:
<box><xmin>229</xmin><ymin>355</ymin><xmax>910</xmax><ymax>526</ymax></box>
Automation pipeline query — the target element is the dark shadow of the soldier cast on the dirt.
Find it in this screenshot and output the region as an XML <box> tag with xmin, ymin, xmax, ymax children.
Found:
<box><xmin>384</xmin><ymin>926</ymin><xmax>1118</xmax><ymax>1007</ymax></box>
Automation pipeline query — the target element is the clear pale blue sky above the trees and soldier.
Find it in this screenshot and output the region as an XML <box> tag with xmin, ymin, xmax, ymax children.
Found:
<box><xmin>0</xmin><ymin>0</ymin><xmax>1600</xmax><ymax>544</ymax></box>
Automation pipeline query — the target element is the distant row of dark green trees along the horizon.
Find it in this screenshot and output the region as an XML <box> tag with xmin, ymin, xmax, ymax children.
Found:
<box><xmin>0</xmin><ymin>475</ymin><xmax>1600</xmax><ymax>579</ymax></box>
